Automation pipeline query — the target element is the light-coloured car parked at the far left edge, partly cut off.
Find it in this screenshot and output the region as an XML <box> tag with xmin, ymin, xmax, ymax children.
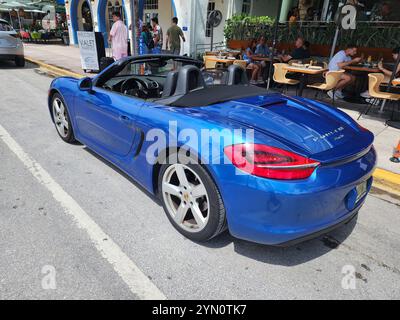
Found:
<box><xmin>0</xmin><ymin>19</ymin><xmax>25</xmax><ymax>67</ymax></box>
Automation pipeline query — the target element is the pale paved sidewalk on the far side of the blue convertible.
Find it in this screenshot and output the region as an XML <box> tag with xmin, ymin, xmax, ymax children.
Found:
<box><xmin>25</xmin><ymin>43</ymin><xmax>400</xmax><ymax>185</ymax></box>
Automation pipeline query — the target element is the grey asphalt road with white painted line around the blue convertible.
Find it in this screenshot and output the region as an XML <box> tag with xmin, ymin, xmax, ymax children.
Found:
<box><xmin>0</xmin><ymin>63</ymin><xmax>400</xmax><ymax>299</ymax></box>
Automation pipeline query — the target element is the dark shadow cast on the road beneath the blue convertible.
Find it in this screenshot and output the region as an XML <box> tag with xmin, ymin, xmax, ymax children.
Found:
<box><xmin>83</xmin><ymin>147</ymin><xmax>357</xmax><ymax>267</ymax></box>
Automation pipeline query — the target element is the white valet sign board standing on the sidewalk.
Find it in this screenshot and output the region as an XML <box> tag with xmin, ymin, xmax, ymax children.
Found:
<box><xmin>78</xmin><ymin>31</ymin><xmax>100</xmax><ymax>70</ymax></box>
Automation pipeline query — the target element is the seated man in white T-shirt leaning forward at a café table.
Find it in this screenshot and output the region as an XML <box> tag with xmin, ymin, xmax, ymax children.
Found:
<box><xmin>328</xmin><ymin>45</ymin><xmax>361</xmax><ymax>99</ymax></box>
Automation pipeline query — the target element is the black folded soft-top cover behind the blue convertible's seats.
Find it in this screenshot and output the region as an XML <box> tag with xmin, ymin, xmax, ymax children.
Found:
<box><xmin>157</xmin><ymin>85</ymin><xmax>268</xmax><ymax>107</ymax></box>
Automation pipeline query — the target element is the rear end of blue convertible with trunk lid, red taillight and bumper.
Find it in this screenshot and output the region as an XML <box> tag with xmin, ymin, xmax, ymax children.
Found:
<box><xmin>202</xmin><ymin>95</ymin><xmax>377</xmax><ymax>246</ymax></box>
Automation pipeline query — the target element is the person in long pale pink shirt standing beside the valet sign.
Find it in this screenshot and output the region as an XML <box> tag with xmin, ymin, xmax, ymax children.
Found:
<box><xmin>108</xmin><ymin>11</ymin><xmax>128</xmax><ymax>60</ymax></box>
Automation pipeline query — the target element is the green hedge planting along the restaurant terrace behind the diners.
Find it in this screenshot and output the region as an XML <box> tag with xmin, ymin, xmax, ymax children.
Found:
<box><xmin>224</xmin><ymin>15</ymin><xmax>400</xmax><ymax>48</ymax></box>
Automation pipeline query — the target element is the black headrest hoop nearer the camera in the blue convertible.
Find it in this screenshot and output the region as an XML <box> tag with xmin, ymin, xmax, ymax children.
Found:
<box><xmin>174</xmin><ymin>65</ymin><xmax>206</xmax><ymax>95</ymax></box>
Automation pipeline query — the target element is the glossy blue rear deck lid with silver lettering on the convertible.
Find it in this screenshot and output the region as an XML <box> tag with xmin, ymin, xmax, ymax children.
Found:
<box><xmin>181</xmin><ymin>94</ymin><xmax>373</xmax><ymax>162</ymax></box>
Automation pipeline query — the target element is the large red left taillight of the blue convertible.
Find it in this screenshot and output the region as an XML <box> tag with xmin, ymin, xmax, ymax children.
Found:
<box><xmin>224</xmin><ymin>144</ymin><xmax>320</xmax><ymax>180</ymax></box>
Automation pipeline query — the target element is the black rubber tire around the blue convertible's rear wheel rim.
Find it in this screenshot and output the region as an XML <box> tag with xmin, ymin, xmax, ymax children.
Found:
<box><xmin>157</xmin><ymin>154</ymin><xmax>226</xmax><ymax>242</ymax></box>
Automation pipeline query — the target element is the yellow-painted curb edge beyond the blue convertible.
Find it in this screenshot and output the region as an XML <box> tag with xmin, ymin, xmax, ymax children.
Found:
<box><xmin>21</xmin><ymin>57</ymin><xmax>400</xmax><ymax>196</ymax></box>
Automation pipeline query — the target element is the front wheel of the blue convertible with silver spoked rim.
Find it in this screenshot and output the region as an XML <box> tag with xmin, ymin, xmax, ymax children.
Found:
<box><xmin>51</xmin><ymin>93</ymin><xmax>75</xmax><ymax>143</ymax></box>
